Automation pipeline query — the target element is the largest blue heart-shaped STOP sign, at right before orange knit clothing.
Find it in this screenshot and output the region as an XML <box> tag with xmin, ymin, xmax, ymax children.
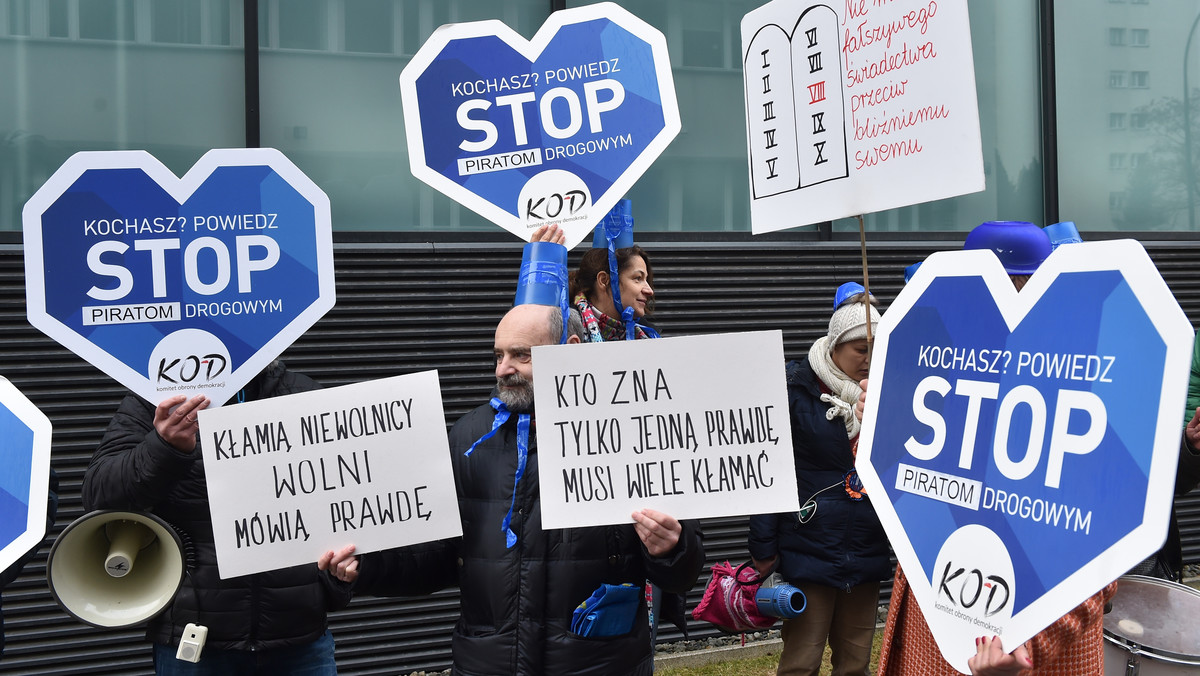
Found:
<box><xmin>858</xmin><ymin>240</ymin><xmax>1193</xmax><ymax>672</ymax></box>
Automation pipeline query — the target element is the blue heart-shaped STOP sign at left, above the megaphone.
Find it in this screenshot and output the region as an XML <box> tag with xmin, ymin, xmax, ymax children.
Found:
<box><xmin>24</xmin><ymin>149</ymin><xmax>334</xmax><ymax>405</ymax></box>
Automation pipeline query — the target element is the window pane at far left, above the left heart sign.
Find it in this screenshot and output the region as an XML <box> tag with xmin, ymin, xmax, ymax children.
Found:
<box><xmin>0</xmin><ymin>0</ymin><xmax>246</xmax><ymax>231</ymax></box>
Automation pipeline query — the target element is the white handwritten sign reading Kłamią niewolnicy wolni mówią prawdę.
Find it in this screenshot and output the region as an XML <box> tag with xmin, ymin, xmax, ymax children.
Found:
<box><xmin>199</xmin><ymin>371</ymin><xmax>462</xmax><ymax>578</ymax></box>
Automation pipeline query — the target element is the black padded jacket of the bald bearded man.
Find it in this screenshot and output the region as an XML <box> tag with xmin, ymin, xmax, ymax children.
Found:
<box><xmin>355</xmin><ymin>405</ymin><xmax>704</xmax><ymax>676</ymax></box>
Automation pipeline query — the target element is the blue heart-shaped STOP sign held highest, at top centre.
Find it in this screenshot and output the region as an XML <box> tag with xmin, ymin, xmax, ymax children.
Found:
<box><xmin>400</xmin><ymin>2</ymin><xmax>679</xmax><ymax>246</ymax></box>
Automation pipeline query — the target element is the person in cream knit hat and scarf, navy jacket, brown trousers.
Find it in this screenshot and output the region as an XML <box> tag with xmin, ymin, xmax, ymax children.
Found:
<box><xmin>749</xmin><ymin>285</ymin><xmax>890</xmax><ymax>676</ymax></box>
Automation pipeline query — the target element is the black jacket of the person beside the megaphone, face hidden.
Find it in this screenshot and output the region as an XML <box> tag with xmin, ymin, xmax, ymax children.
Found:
<box><xmin>83</xmin><ymin>361</ymin><xmax>350</xmax><ymax>651</ymax></box>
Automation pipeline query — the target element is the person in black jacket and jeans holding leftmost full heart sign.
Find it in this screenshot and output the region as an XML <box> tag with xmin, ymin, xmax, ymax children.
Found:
<box><xmin>83</xmin><ymin>361</ymin><xmax>350</xmax><ymax>676</ymax></box>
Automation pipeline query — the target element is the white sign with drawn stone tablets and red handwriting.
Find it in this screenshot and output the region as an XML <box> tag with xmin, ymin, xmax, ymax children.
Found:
<box><xmin>742</xmin><ymin>0</ymin><xmax>984</xmax><ymax>234</ymax></box>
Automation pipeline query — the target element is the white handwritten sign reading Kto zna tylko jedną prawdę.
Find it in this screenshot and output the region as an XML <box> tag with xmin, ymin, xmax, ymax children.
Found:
<box><xmin>533</xmin><ymin>331</ymin><xmax>799</xmax><ymax>528</ymax></box>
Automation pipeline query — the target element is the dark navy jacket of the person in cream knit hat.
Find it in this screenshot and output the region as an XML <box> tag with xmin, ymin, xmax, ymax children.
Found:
<box><xmin>749</xmin><ymin>359</ymin><xmax>890</xmax><ymax>590</ymax></box>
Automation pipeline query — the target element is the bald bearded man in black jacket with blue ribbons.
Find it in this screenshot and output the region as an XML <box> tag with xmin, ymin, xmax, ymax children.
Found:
<box><xmin>319</xmin><ymin>238</ymin><xmax>704</xmax><ymax>676</ymax></box>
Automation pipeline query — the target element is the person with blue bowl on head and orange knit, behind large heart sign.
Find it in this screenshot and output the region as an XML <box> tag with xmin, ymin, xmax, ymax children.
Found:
<box><xmin>873</xmin><ymin>221</ymin><xmax>1116</xmax><ymax>676</ymax></box>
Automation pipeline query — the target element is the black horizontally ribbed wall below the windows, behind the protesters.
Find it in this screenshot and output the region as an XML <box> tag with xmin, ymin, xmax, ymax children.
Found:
<box><xmin>0</xmin><ymin>241</ymin><xmax>1200</xmax><ymax>675</ymax></box>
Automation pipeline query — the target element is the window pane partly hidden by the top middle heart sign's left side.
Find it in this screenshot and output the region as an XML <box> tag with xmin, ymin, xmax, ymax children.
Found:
<box><xmin>260</xmin><ymin>0</ymin><xmax>549</xmax><ymax>232</ymax></box>
